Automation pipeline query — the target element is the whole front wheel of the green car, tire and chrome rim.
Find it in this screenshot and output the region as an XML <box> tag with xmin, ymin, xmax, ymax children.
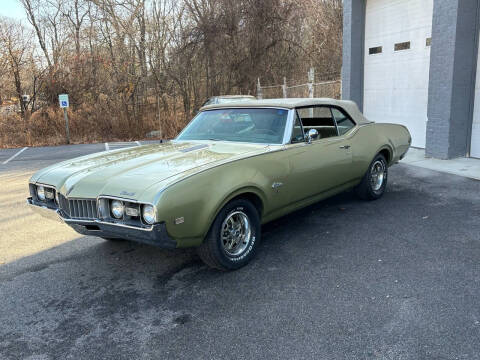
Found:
<box><xmin>198</xmin><ymin>199</ymin><xmax>261</xmax><ymax>271</ymax></box>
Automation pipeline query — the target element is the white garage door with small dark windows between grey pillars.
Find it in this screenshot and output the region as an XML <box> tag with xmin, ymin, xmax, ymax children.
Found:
<box><xmin>363</xmin><ymin>0</ymin><xmax>433</xmax><ymax>148</ymax></box>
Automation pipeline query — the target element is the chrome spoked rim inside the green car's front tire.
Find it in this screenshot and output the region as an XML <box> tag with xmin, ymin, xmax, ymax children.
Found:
<box><xmin>221</xmin><ymin>210</ymin><xmax>252</xmax><ymax>256</ymax></box>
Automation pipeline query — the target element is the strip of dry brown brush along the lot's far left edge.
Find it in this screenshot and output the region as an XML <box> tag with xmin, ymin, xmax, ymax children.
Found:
<box><xmin>0</xmin><ymin>102</ymin><xmax>186</xmax><ymax>148</ymax></box>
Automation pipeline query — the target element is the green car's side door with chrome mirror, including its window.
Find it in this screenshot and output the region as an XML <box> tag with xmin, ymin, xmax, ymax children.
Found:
<box><xmin>287</xmin><ymin>106</ymin><xmax>352</xmax><ymax>203</ymax></box>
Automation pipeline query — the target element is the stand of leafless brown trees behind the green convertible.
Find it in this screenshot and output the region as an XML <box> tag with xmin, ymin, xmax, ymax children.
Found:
<box><xmin>0</xmin><ymin>0</ymin><xmax>343</xmax><ymax>146</ymax></box>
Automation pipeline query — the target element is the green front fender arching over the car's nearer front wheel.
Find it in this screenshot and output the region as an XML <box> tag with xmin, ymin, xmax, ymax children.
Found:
<box><xmin>157</xmin><ymin>151</ymin><xmax>289</xmax><ymax>247</ymax></box>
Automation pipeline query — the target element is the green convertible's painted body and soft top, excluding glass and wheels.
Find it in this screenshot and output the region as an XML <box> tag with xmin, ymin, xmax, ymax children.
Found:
<box><xmin>28</xmin><ymin>99</ymin><xmax>411</xmax><ymax>268</ymax></box>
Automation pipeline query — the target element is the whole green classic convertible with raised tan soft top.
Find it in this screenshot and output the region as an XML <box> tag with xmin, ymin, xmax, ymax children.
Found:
<box><xmin>28</xmin><ymin>99</ymin><xmax>411</xmax><ymax>270</ymax></box>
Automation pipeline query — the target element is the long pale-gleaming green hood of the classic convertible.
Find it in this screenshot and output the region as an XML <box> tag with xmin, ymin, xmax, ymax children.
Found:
<box><xmin>30</xmin><ymin>141</ymin><xmax>271</xmax><ymax>199</ymax></box>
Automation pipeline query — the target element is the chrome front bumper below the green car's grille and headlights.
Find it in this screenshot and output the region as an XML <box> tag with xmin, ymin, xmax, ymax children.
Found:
<box><xmin>27</xmin><ymin>198</ymin><xmax>177</xmax><ymax>249</ymax></box>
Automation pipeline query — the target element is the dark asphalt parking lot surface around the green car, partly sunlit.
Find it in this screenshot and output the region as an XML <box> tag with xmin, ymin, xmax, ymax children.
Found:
<box><xmin>0</xmin><ymin>144</ymin><xmax>480</xmax><ymax>360</ymax></box>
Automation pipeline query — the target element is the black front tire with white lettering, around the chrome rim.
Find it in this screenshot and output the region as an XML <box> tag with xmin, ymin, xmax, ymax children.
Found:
<box><xmin>197</xmin><ymin>199</ymin><xmax>261</xmax><ymax>271</ymax></box>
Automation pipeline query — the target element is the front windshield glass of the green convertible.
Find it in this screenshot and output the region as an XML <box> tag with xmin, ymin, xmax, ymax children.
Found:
<box><xmin>177</xmin><ymin>108</ymin><xmax>288</xmax><ymax>144</ymax></box>
